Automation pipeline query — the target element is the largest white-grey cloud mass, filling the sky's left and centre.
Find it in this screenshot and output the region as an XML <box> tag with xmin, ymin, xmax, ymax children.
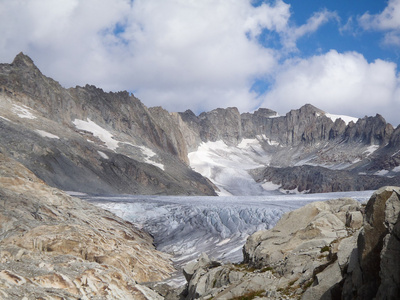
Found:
<box><xmin>0</xmin><ymin>0</ymin><xmax>338</xmax><ymax>115</ymax></box>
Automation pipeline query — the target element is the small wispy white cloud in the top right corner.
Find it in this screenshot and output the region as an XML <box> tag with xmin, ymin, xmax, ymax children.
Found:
<box><xmin>358</xmin><ymin>0</ymin><xmax>400</xmax><ymax>46</ymax></box>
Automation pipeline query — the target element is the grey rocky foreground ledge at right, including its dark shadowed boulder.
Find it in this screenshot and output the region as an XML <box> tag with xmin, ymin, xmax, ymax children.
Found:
<box><xmin>181</xmin><ymin>187</ymin><xmax>400</xmax><ymax>300</ymax></box>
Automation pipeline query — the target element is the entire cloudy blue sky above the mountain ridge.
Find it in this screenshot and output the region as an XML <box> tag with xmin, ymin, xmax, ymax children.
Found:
<box><xmin>0</xmin><ymin>0</ymin><xmax>400</xmax><ymax>126</ymax></box>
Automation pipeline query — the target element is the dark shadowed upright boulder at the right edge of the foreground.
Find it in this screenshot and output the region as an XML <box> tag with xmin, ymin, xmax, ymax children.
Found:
<box><xmin>343</xmin><ymin>187</ymin><xmax>400</xmax><ymax>299</ymax></box>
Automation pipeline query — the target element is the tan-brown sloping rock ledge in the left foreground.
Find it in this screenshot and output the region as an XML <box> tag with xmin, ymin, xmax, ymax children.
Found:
<box><xmin>0</xmin><ymin>153</ymin><xmax>173</xmax><ymax>300</ymax></box>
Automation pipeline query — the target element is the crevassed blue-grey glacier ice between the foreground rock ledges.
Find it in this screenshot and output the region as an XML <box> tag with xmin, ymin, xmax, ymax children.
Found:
<box><xmin>80</xmin><ymin>191</ymin><xmax>372</xmax><ymax>284</ymax></box>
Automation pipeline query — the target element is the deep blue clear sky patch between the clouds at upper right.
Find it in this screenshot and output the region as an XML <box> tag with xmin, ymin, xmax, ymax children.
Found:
<box><xmin>287</xmin><ymin>0</ymin><xmax>398</xmax><ymax>61</ymax></box>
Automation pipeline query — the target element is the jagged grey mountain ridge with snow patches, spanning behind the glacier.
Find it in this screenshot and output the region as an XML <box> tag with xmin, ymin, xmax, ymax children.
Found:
<box><xmin>0</xmin><ymin>52</ymin><xmax>400</xmax><ymax>195</ymax></box>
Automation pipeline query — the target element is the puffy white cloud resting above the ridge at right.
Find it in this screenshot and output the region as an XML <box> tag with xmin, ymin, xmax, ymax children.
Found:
<box><xmin>263</xmin><ymin>50</ymin><xmax>400</xmax><ymax>125</ymax></box>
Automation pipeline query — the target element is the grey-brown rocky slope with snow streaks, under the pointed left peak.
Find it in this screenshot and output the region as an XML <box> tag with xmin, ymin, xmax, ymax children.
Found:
<box><xmin>0</xmin><ymin>53</ymin><xmax>215</xmax><ymax>195</ymax></box>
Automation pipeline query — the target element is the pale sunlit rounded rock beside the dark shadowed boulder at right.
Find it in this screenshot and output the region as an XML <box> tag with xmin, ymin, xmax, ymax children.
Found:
<box><xmin>243</xmin><ymin>198</ymin><xmax>361</xmax><ymax>267</ymax></box>
